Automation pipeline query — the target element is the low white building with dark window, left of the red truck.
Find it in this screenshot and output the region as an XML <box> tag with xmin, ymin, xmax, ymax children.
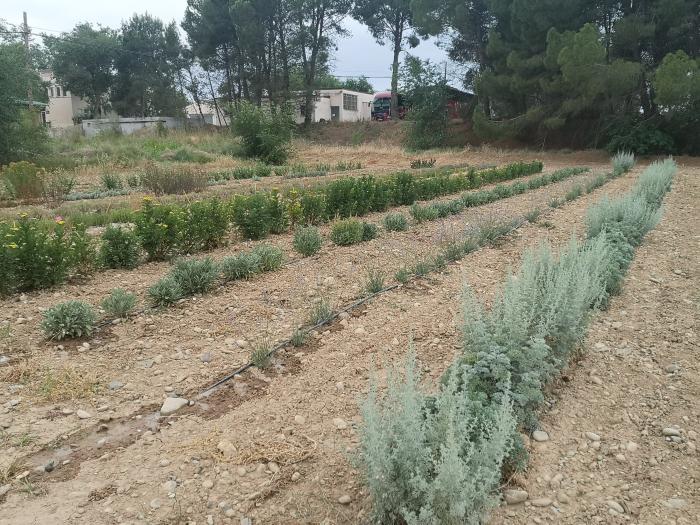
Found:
<box><xmin>295</xmin><ymin>89</ymin><xmax>374</xmax><ymax>124</ymax></box>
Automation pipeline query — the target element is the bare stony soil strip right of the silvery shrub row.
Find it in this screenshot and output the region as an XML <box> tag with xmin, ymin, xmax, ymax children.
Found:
<box><xmin>491</xmin><ymin>168</ymin><xmax>700</xmax><ymax>525</ymax></box>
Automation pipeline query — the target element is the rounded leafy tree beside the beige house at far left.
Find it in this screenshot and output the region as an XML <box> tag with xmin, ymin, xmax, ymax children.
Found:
<box><xmin>44</xmin><ymin>24</ymin><xmax>119</xmax><ymax>116</ymax></box>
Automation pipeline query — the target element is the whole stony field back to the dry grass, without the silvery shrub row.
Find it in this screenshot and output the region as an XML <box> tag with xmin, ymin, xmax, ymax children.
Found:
<box><xmin>0</xmin><ymin>127</ymin><xmax>700</xmax><ymax>524</ymax></box>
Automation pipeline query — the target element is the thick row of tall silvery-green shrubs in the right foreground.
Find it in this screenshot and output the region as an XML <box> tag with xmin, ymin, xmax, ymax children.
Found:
<box><xmin>360</xmin><ymin>156</ymin><xmax>676</xmax><ymax>523</ymax></box>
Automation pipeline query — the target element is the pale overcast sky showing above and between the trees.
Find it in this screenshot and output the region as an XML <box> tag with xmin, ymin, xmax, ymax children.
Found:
<box><xmin>0</xmin><ymin>0</ymin><xmax>446</xmax><ymax>89</ymax></box>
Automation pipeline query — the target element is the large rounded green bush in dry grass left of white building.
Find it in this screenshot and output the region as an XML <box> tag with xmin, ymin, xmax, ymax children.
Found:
<box><xmin>231</xmin><ymin>101</ymin><xmax>294</xmax><ymax>164</ymax></box>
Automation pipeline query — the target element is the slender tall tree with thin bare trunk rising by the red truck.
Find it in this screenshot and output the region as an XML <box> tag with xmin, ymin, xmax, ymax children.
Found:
<box><xmin>352</xmin><ymin>0</ymin><xmax>418</xmax><ymax>116</ymax></box>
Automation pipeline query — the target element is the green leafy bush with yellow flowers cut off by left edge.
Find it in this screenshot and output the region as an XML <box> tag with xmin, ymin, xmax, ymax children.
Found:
<box><xmin>0</xmin><ymin>214</ymin><xmax>91</xmax><ymax>295</ymax></box>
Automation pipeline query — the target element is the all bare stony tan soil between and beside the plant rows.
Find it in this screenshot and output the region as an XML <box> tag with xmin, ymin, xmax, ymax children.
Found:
<box><xmin>0</xmin><ymin>152</ymin><xmax>700</xmax><ymax>524</ymax></box>
